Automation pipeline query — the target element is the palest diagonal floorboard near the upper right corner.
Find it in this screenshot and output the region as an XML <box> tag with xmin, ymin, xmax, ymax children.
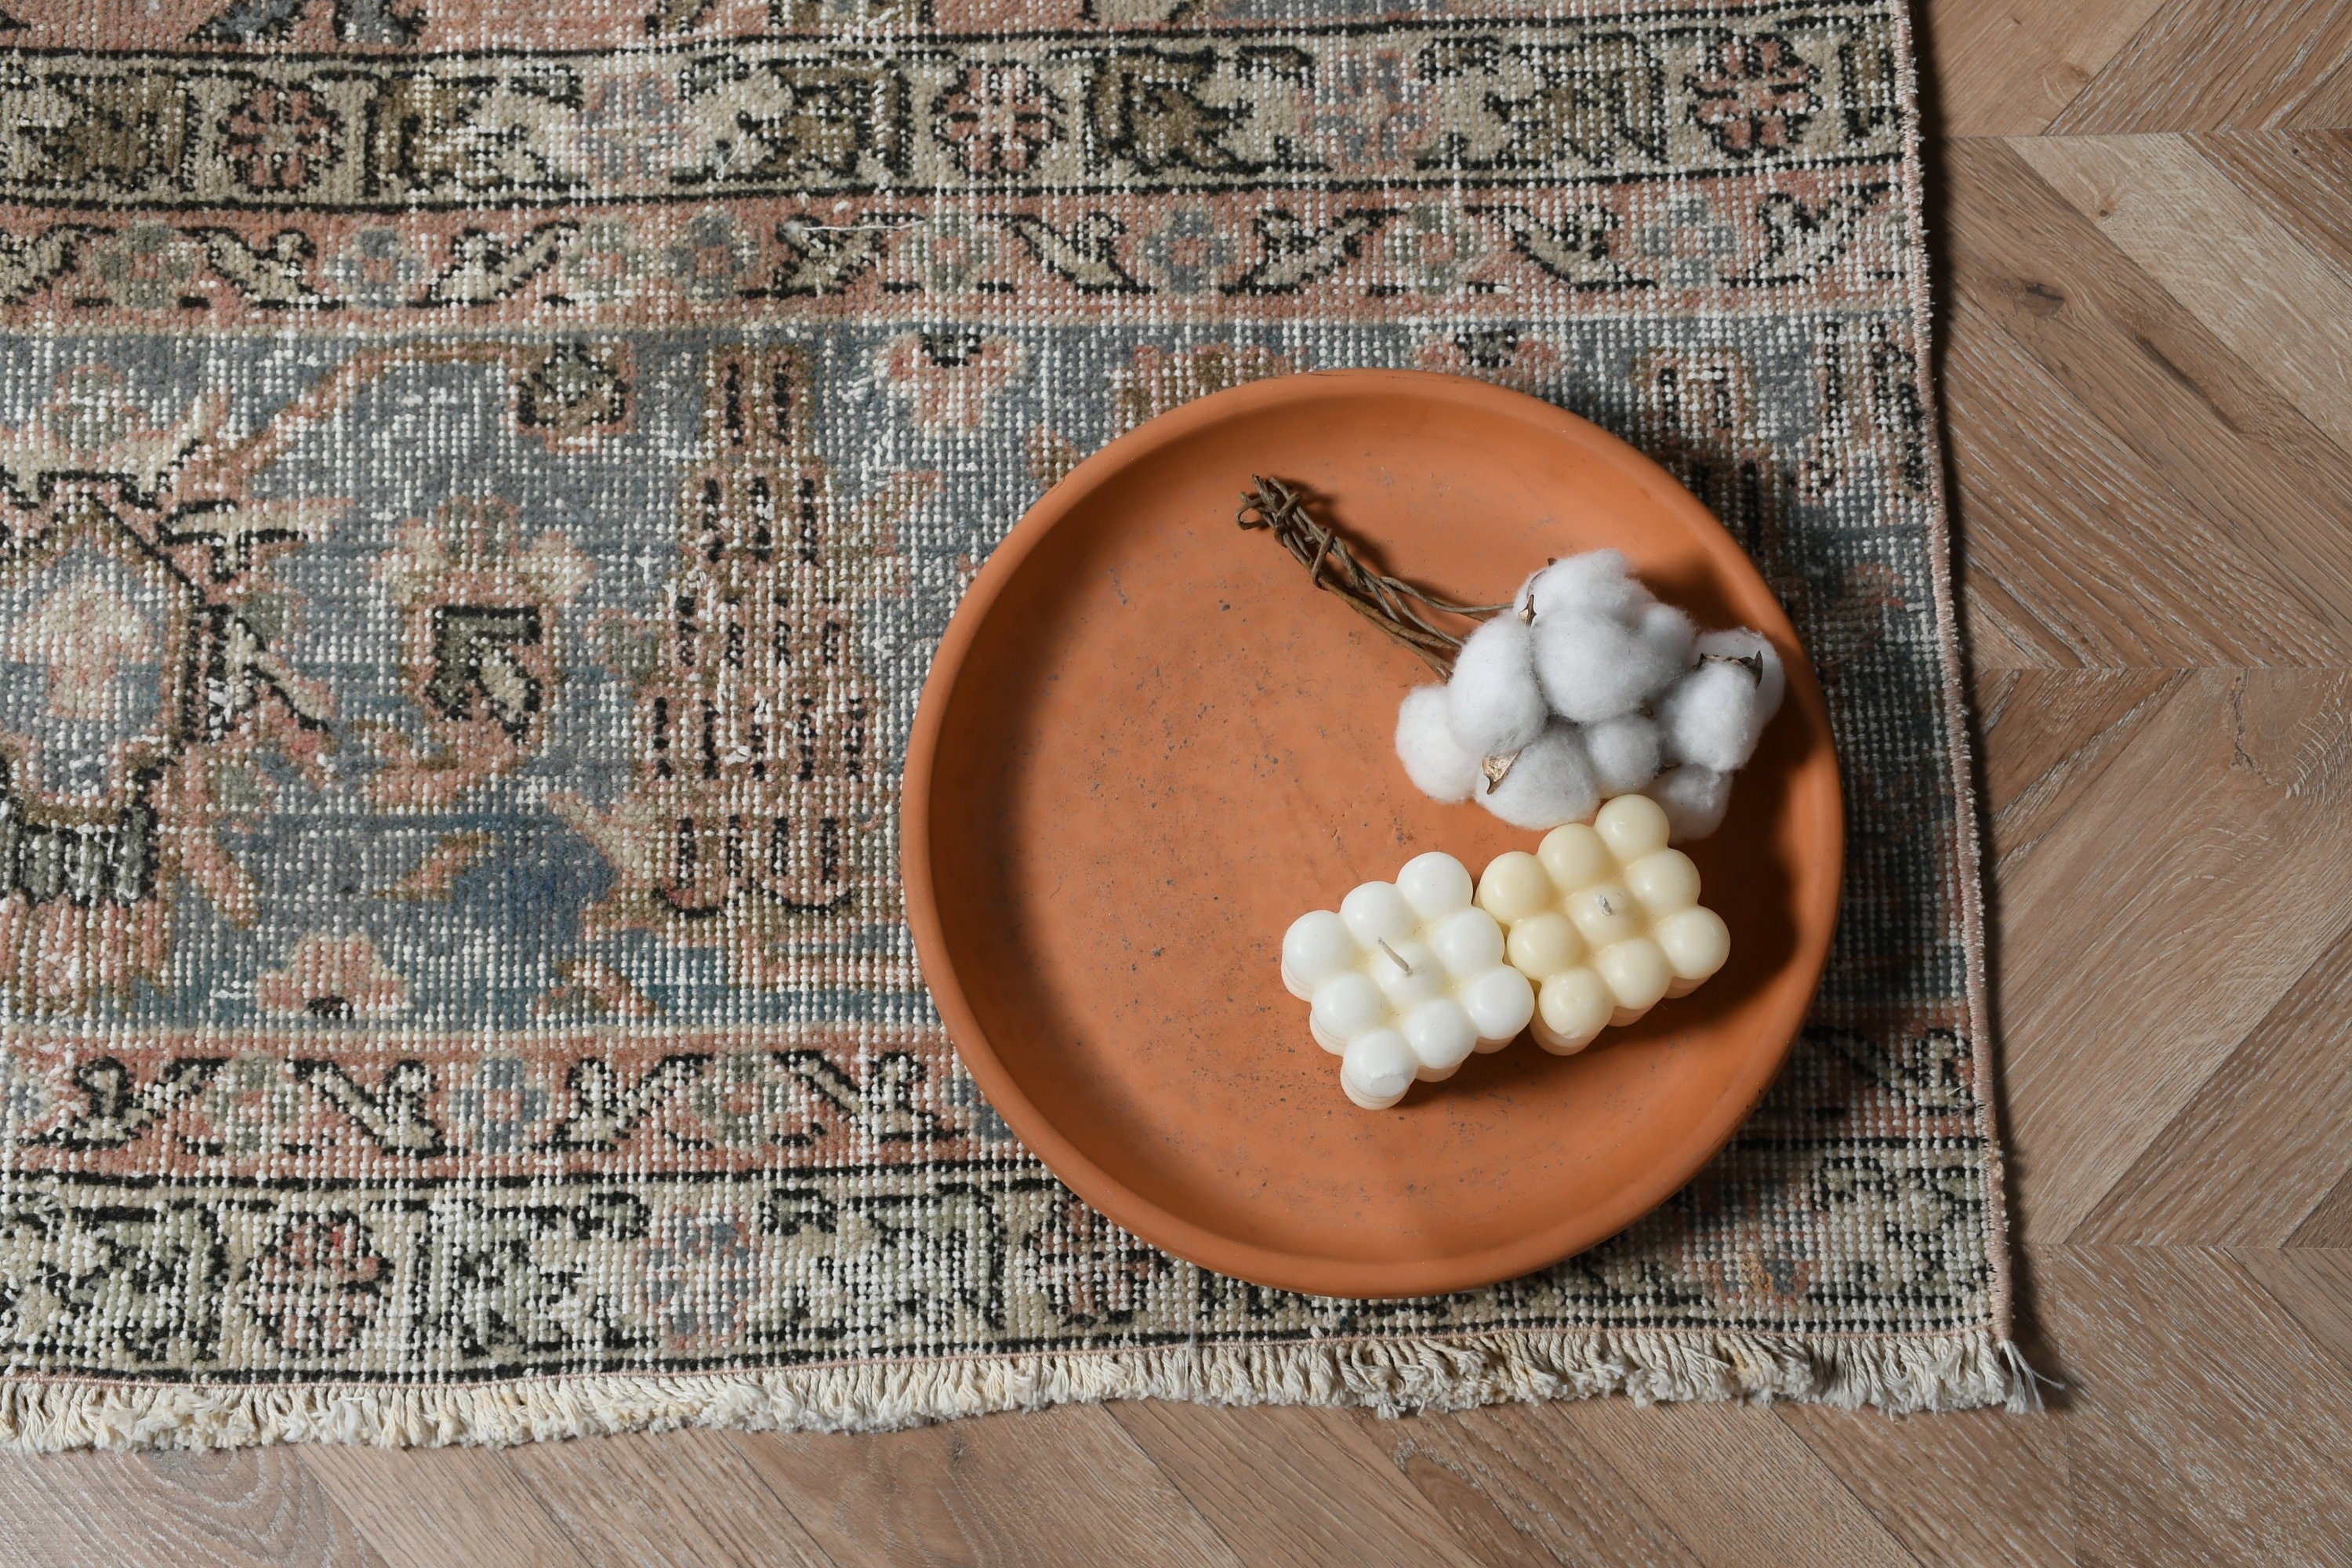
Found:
<box><xmin>2011</xmin><ymin>136</ymin><xmax>2352</xmax><ymax>445</ymax></box>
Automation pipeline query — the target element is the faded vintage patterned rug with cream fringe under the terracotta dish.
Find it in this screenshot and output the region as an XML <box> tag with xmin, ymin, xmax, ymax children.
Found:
<box><xmin>0</xmin><ymin>0</ymin><xmax>2030</xmax><ymax>1446</ymax></box>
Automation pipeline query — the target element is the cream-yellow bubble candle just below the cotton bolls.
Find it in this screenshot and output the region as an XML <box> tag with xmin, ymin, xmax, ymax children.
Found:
<box><xmin>1477</xmin><ymin>794</ymin><xmax>1731</xmax><ymax>1055</ymax></box>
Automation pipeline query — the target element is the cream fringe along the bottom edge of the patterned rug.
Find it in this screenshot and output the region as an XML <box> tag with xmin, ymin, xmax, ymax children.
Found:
<box><xmin>0</xmin><ymin>1328</ymin><xmax>2042</xmax><ymax>1450</ymax></box>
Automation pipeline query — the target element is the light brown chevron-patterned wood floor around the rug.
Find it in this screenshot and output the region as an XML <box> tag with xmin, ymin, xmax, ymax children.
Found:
<box><xmin>0</xmin><ymin>0</ymin><xmax>2352</xmax><ymax>1568</ymax></box>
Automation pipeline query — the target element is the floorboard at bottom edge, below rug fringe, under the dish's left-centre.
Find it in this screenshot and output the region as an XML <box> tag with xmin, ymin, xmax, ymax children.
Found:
<box><xmin>1110</xmin><ymin>1399</ymin><xmax>1477</xmax><ymax>1568</ymax></box>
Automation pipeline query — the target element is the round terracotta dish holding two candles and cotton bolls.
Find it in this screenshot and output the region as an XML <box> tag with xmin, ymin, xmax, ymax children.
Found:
<box><xmin>903</xmin><ymin>372</ymin><xmax>1844</xmax><ymax>1295</ymax></box>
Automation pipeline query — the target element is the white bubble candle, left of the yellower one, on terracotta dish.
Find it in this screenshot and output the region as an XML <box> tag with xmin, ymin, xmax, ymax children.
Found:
<box><xmin>1282</xmin><ymin>853</ymin><xmax>1536</xmax><ymax>1109</ymax></box>
